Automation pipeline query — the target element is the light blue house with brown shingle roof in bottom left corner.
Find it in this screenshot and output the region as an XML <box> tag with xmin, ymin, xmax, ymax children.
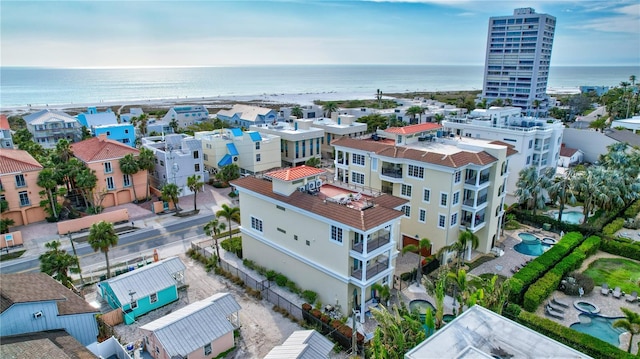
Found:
<box><xmin>0</xmin><ymin>273</ymin><xmax>99</xmax><ymax>346</ymax></box>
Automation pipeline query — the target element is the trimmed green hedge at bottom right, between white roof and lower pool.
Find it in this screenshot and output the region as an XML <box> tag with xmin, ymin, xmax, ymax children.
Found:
<box><xmin>516</xmin><ymin>311</ymin><xmax>638</xmax><ymax>359</ymax></box>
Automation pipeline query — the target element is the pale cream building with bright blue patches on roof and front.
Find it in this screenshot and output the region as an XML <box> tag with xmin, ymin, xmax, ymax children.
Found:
<box><xmin>194</xmin><ymin>128</ymin><xmax>280</xmax><ymax>174</ymax></box>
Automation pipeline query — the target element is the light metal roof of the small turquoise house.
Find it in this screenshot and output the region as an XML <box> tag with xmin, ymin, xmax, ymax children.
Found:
<box><xmin>103</xmin><ymin>257</ymin><xmax>186</xmax><ymax>305</ymax></box>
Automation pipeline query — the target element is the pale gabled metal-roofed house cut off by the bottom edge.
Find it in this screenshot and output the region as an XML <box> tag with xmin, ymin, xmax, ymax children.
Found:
<box><xmin>264</xmin><ymin>330</ymin><xmax>333</xmax><ymax>359</ymax></box>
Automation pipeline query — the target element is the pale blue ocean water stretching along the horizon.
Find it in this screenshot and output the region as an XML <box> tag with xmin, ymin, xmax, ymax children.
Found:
<box><xmin>0</xmin><ymin>65</ymin><xmax>640</xmax><ymax>108</ymax></box>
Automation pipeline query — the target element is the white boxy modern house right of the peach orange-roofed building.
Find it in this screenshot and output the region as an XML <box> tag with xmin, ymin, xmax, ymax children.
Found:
<box><xmin>142</xmin><ymin>134</ymin><xmax>209</xmax><ymax>196</ymax></box>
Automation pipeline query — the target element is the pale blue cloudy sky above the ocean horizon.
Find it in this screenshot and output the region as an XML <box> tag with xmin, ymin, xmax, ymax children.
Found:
<box><xmin>0</xmin><ymin>0</ymin><xmax>640</xmax><ymax>68</ymax></box>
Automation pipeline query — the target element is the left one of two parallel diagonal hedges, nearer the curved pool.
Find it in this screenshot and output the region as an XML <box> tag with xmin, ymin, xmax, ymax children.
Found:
<box><xmin>510</xmin><ymin>232</ymin><xmax>584</xmax><ymax>303</ymax></box>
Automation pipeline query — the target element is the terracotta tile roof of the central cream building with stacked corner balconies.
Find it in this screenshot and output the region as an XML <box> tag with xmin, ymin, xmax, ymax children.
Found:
<box><xmin>232</xmin><ymin>177</ymin><xmax>408</xmax><ymax>231</ymax></box>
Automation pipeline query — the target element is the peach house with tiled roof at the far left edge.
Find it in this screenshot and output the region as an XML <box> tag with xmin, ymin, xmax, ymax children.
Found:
<box><xmin>0</xmin><ymin>148</ymin><xmax>46</xmax><ymax>226</ymax></box>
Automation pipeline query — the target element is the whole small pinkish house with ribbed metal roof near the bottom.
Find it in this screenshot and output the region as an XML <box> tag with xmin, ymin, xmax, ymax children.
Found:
<box><xmin>140</xmin><ymin>293</ymin><xmax>240</xmax><ymax>359</ymax></box>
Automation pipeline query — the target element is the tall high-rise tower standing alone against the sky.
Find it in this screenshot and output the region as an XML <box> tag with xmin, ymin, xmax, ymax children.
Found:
<box><xmin>482</xmin><ymin>8</ymin><xmax>556</xmax><ymax>114</ymax></box>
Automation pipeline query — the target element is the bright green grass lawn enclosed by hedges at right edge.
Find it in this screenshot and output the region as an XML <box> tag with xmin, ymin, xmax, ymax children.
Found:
<box><xmin>584</xmin><ymin>258</ymin><xmax>640</xmax><ymax>293</ymax></box>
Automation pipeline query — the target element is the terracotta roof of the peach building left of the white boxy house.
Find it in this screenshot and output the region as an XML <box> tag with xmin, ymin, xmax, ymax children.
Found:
<box><xmin>71</xmin><ymin>136</ymin><xmax>140</xmax><ymax>163</ymax></box>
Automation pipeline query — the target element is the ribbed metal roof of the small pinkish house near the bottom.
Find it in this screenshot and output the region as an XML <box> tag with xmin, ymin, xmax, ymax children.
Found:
<box><xmin>140</xmin><ymin>293</ymin><xmax>241</xmax><ymax>357</ymax></box>
